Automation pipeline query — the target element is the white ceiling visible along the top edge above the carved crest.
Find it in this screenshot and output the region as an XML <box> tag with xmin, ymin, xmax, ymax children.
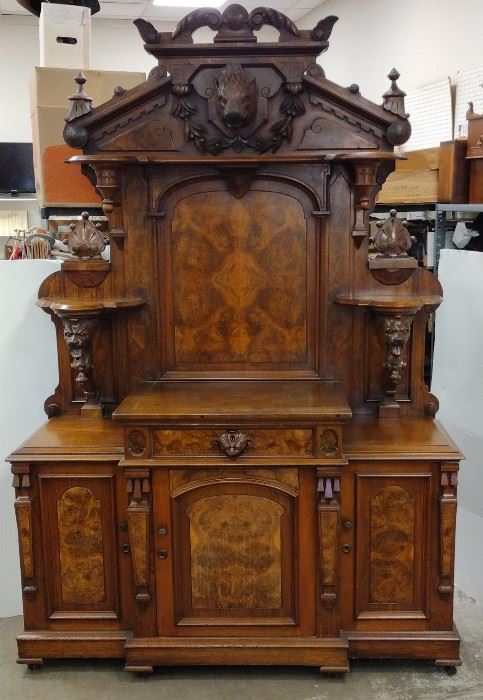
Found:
<box><xmin>0</xmin><ymin>0</ymin><xmax>323</xmax><ymax>22</ymax></box>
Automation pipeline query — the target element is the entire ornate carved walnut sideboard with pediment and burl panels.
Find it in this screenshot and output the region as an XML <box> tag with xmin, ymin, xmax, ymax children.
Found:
<box><xmin>6</xmin><ymin>0</ymin><xmax>461</xmax><ymax>673</ymax></box>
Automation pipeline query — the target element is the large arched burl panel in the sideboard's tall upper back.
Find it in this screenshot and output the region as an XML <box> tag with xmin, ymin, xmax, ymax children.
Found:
<box><xmin>172</xmin><ymin>186</ymin><xmax>308</xmax><ymax>369</ymax></box>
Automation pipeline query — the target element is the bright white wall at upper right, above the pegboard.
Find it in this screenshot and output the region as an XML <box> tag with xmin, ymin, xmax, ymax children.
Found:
<box><xmin>298</xmin><ymin>0</ymin><xmax>483</xmax><ymax>103</ymax></box>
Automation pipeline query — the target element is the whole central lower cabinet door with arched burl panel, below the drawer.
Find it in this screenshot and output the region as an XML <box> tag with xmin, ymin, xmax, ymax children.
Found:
<box><xmin>154</xmin><ymin>467</ymin><xmax>315</xmax><ymax>636</ymax></box>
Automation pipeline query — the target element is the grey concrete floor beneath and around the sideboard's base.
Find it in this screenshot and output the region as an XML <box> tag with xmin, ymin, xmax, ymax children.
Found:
<box><xmin>0</xmin><ymin>594</ymin><xmax>483</xmax><ymax>700</ymax></box>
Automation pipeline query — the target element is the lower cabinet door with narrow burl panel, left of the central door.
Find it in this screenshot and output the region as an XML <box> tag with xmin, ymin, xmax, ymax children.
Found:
<box><xmin>39</xmin><ymin>465</ymin><xmax>130</xmax><ymax>629</ymax></box>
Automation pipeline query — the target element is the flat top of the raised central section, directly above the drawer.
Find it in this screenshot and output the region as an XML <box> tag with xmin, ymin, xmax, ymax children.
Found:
<box><xmin>113</xmin><ymin>380</ymin><xmax>351</xmax><ymax>421</ymax></box>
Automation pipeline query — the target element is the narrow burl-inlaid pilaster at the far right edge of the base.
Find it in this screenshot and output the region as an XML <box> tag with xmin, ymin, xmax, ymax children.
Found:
<box><xmin>438</xmin><ymin>462</ymin><xmax>458</xmax><ymax>595</ymax></box>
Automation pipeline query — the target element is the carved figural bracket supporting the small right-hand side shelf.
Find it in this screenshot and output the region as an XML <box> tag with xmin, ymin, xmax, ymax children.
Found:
<box><xmin>379</xmin><ymin>310</ymin><xmax>416</xmax><ymax>415</ymax></box>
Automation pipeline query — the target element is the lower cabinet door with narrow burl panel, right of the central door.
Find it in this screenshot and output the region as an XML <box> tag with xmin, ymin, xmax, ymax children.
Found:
<box><xmin>341</xmin><ymin>464</ymin><xmax>435</xmax><ymax>629</ymax></box>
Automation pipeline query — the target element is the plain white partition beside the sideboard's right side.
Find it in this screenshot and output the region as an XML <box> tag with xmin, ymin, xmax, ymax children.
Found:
<box><xmin>431</xmin><ymin>250</ymin><xmax>483</xmax><ymax>602</ymax></box>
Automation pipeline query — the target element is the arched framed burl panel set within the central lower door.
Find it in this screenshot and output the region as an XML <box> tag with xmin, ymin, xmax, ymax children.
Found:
<box><xmin>173</xmin><ymin>482</ymin><xmax>295</xmax><ymax>624</ymax></box>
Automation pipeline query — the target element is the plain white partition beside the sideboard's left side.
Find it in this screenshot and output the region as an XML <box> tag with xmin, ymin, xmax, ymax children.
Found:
<box><xmin>0</xmin><ymin>260</ymin><xmax>60</xmax><ymax>617</ymax></box>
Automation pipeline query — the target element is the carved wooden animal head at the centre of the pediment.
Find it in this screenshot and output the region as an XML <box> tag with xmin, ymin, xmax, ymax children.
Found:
<box><xmin>216</xmin><ymin>63</ymin><xmax>257</xmax><ymax>129</ymax></box>
